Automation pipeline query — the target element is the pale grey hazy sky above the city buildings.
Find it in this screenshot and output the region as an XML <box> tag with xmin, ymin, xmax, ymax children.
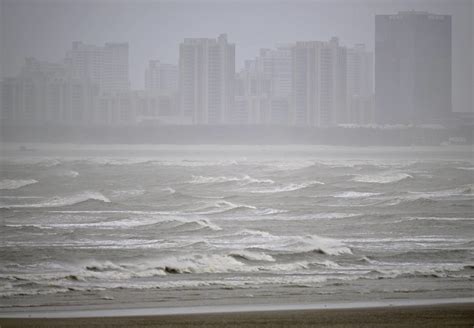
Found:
<box><xmin>0</xmin><ymin>0</ymin><xmax>474</xmax><ymax>111</ymax></box>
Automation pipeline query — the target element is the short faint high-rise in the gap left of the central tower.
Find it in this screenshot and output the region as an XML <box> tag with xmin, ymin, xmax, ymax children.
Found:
<box><xmin>145</xmin><ymin>60</ymin><xmax>178</xmax><ymax>93</ymax></box>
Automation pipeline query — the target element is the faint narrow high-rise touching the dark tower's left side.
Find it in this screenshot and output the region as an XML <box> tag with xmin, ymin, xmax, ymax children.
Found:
<box><xmin>346</xmin><ymin>44</ymin><xmax>374</xmax><ymax>125</ymax></box>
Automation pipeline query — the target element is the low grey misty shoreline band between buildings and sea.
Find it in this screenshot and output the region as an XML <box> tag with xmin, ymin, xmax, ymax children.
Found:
<box><xmin>0</xmin><ymin>124</ymin><xmax>474</xmax><ymax>146</ymax></box>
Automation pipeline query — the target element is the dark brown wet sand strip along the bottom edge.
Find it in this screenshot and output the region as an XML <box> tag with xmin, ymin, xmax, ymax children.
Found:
<box><xmin>0</xmin><ymin>303</ymin><xmax>474</xmax><ymax>328</ymax></box>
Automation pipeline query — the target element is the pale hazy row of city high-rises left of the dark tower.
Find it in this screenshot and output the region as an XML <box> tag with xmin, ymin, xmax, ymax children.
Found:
<box><xmin>2</xmin><ymin>34</ymin><xmax>376</xmax><ymax>127</ymax></box>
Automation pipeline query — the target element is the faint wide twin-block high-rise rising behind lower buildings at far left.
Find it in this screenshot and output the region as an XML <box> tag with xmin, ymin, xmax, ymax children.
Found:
<box><xmin>65</xmin><ymin>42</ymin><xmax>130</xmax><ymax>93</ymax></box>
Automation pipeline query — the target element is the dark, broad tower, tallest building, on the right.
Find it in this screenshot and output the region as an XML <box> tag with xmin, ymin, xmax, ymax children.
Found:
<box><xmin>375</xmin><ymin>11</ymin><xmax>451</xmax><ymax>124</ymax></box>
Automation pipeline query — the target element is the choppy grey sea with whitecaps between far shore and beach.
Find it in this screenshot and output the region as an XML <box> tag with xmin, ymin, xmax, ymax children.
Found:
<box><xmin>0</xmin><ymin>145</ymin><xmax>474</xmax><ymax>306</ymax></box>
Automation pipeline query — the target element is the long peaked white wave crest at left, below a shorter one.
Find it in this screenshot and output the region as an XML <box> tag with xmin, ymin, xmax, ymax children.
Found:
<box><xmin>0</xmin><ymin>191</ymin><xmax>110</xmax><ymax>209</ymax></box>
